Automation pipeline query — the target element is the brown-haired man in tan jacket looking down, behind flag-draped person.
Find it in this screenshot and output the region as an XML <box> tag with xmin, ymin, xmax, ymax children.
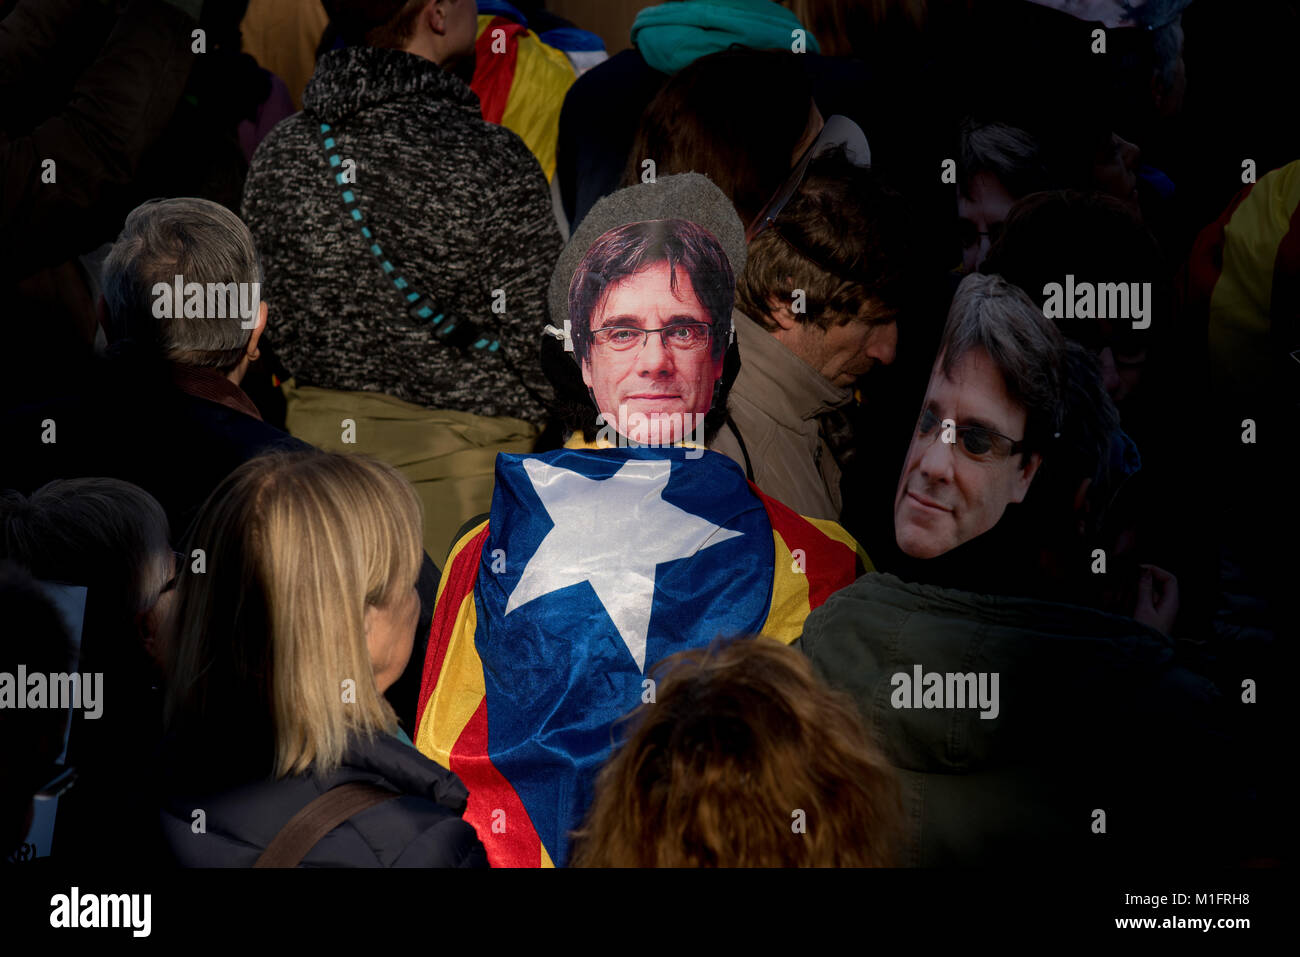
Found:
<box><xmin>711</xmin><ymin>151</ymin><xmax>913</xmax><ymax>520</ymax></box>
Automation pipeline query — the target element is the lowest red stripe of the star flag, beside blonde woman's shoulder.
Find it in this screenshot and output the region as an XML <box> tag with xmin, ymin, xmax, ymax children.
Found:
<box><xmin>450</xmin><ymin>698</ymin><xmax>542</xmax><ymax>867</ymax></box>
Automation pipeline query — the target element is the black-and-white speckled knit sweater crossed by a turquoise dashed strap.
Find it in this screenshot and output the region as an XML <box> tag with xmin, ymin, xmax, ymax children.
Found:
<box><xmin>243</xmin><ymin>47</ymin><xmax>560</xmax><ymax>421</ymax></box>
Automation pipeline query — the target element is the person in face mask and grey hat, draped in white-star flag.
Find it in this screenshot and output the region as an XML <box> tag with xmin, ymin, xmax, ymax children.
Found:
<box><xmin>416</xmin><ymin>173</ymin><xmax>865</xmax><ymax>867</ymax></box>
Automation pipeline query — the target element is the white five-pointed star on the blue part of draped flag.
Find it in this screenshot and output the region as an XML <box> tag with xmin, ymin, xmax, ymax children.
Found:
<box><xmin>506</xmin><ymin>459</ymin><xmax>744</xmax><ymax>672</ymax></box>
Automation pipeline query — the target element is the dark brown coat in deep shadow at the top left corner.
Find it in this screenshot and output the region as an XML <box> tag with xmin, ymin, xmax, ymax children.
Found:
<box><xmin>0</xmin><ymin>0</ymin><xmax>199</xmax><ymax>408</ymax></box>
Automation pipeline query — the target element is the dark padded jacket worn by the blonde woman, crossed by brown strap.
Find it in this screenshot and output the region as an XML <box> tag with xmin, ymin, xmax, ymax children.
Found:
<box><xmin>161</xmin><ymin>732</ymin><xmax>488</xmax><ymax>867</ymax></box>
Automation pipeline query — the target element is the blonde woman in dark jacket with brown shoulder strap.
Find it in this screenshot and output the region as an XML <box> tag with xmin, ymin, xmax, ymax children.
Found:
<box><xmin>163</xmin><ymin>451</ymin><xmax>486</xmax><ymax>867</ymax></box>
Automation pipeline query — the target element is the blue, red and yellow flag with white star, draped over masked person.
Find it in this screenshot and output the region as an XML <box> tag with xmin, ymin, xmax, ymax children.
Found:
<box><xmin>416</xmin><ymin>447</ymin><xmax>870</xmax><ymax>867</ymax></box>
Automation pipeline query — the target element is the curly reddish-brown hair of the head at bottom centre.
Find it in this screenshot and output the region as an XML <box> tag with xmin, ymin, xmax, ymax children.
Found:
<box><xmin>572</xmin><ymin>637</ymin><xmax>902</xmax><ymax>867</ymax></box>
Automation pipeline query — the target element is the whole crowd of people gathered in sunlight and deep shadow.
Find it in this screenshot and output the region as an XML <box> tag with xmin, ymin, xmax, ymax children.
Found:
<box><xmin>0</xmin><ymin>0</ymin><xmax>1284</xmax><ymax>867</ymax></box>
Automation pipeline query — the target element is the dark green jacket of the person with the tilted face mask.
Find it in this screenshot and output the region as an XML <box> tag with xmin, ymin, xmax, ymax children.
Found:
<box><xmin>796</xmin><ymin>573</ymin><xmax>1231</xmax><ymax>866</ymax></box>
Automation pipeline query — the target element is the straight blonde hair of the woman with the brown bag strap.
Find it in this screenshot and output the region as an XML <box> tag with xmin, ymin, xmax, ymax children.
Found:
<box><xmin>166</xmin><ymin>451</ymin><xmax>423</xmax><ymax>778</ymax></box>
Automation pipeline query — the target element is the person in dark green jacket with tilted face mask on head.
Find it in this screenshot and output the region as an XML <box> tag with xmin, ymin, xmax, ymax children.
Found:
<box><xmin>797</xmin><ymin>276</ymin><xmax>1245</xmax><ymax>866</ymax></box>
